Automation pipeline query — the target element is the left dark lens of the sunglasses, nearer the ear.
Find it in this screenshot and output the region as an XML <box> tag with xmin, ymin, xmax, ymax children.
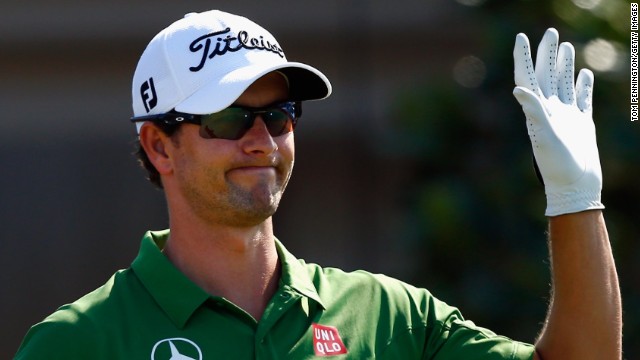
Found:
<box><xmin>200</xmin><ymin>108</ymin><xmax>253</xmax><ymax>140</ymax></box>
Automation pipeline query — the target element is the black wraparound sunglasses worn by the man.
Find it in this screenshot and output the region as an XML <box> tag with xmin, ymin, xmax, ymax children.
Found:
<box><xmin>131</xmin><ymin>102</ymin><xmax>302</xmax><ymax>140</ymax></box>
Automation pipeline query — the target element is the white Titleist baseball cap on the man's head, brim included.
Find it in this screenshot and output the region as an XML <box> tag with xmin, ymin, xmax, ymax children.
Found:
<box><xmin>132</xmin><ymin>10</ymin><xmax>331</xmax><ymax>125</ymax></box>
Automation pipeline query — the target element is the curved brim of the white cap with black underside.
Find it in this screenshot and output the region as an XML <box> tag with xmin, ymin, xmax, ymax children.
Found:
<box><xmin>175</xmin><ymin>62</ymin><xmax>331</xmax><ymax>114</ymax></box>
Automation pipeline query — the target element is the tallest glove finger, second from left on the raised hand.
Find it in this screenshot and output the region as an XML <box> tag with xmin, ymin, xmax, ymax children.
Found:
<box><xmin>535</xmin><ymin>28</ymin><xmax>559</xmax><ymax>98</ymax></box>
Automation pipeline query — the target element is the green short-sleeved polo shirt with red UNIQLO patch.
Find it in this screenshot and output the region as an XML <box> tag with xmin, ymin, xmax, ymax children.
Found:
<box><xmin>16</xmin><ymin>231</ymin><xmax>534</xmax><ymax>360</ymax></box>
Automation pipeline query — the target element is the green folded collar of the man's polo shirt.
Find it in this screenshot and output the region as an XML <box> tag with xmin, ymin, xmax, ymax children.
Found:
<box><xmin>131</xmin><ymin>230</ymin><xmax>324</xmax><ymax>328</ymax></box>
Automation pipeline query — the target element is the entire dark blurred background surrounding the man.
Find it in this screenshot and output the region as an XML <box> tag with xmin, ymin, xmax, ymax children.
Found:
<box><xmin>0</xmin><ymin>0</ymin><xmax>640</xmax><ymax>359</ymax></box>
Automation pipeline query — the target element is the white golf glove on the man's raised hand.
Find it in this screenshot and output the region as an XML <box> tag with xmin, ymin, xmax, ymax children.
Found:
<box><xmin>513</xmin><ymin>29</ymin><xmax>604</xmax><ymax>216</ymax></box>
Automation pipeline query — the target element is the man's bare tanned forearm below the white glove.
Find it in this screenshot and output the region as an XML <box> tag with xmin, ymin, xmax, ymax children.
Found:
<box><xmin>536</xmin><ymin>210</ymin><xmax>622</xmax><ymax>360</ymax></box>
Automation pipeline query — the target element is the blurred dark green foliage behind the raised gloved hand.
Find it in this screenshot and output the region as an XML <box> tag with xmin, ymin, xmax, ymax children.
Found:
<box><xmin>384</xmin><ymin>0</ymin><xmax>640</xmax><ymax>359</ymax></box>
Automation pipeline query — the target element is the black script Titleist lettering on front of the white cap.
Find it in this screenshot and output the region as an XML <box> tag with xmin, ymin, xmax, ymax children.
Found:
<box><xmin>189</xmin><ymin>28</ymin><xmax>284</xmax><ymax>72</ymax></box>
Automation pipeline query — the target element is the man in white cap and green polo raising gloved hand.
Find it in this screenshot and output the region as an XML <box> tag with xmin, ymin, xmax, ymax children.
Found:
<box><xmin>16</xmin><ymin>11</ymin><xmax>621</xmax><ymax>360</ymax></box>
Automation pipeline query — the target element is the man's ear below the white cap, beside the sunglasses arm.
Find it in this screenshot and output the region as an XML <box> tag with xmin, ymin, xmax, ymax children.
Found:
<box><xmin>140</xmin><ymin>122</ymin><xmax>173</xmax><ymax>175</ymax></box>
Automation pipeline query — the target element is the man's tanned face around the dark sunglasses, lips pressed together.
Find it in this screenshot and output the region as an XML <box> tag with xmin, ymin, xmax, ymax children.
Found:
<box><xmin>166</xmin><ymin>73</ymin><xmax>294</xmax><ymax>226</ymax></box>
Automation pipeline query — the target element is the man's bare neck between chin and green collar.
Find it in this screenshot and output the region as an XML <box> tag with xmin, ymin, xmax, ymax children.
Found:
<box><xmin>164</xmin><ymin>218</ymin><xmax>279</xmax><ymax>320</ymax></box>
